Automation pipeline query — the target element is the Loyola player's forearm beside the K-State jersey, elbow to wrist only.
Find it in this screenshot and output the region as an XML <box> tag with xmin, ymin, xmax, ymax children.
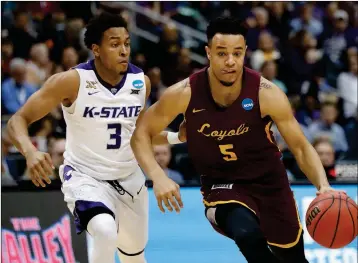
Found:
<box><xmin>131</xmin><ymin>128</ymin><xmax>166</xmax><ymax>181</ymax></box>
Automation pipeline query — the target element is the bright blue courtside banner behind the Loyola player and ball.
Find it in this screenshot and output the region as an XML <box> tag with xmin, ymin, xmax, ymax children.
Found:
<box><xmin>86</xmin><ymin>185</ymin><xmax>358</xmax><ymax>263</ymax></box>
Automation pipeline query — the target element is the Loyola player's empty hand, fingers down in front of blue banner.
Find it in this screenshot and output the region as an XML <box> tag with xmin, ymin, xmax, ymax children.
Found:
<box><xmin>153</xmin><ymin>170</ymin><xmax>183</xmax><ymax>213</ymax></box>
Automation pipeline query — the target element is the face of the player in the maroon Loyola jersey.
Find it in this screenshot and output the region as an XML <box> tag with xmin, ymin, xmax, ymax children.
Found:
<box><xmin>205</xmin><ymin>34</ymin><xmax>246</xmax><ymax>87</ymax></box>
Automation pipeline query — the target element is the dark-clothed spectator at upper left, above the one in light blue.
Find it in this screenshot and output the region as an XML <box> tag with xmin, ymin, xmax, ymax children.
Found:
<box><xmin>9</xmin><ymin>12</ymin><xmax>36</xmax><ymax>59</ymax></box>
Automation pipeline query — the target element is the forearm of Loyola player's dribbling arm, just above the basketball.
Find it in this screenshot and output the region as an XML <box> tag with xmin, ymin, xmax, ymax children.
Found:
<box><xmin>295</xmin><ymin>143</ymin><xmax>329</xmax><ymax>190</ymax></box>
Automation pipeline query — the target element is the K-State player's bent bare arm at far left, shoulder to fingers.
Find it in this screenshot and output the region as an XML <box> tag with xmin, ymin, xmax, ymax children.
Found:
<box><xmin>7</xmin><ymin>70</ymin><xmax>79</xmax><ymax>187</ymax></box>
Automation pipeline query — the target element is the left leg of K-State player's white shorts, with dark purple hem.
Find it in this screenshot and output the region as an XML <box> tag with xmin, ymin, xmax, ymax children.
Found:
<box><xmin>59</xmin><ymin>166</ymin><xmax>116</xmax><ymax>233</ymax></box>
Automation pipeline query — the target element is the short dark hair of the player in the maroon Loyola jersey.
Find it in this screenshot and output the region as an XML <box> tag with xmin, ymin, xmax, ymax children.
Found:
<box><xmin>206</xmin><ymin>17</ymin><xmax>247</xmax><ymax>43</ymax></box>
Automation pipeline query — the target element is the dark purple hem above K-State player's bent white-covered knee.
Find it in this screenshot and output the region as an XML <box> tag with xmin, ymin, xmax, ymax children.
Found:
<box><xmin>73</xmin><ymin>200</ymin><xmax>114</xmax><ymax>235</ymax></box>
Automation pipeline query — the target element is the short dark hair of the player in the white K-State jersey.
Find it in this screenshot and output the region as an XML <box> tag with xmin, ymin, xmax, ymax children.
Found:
<box><xmin>84</xmin><ymin>12</ymin><xmax>128</xmax><ymax>49</ymax></box>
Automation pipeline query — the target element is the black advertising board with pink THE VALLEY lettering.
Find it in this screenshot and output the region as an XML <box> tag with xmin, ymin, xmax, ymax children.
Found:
<box><xmin>1</xmin><ymin>190</ymin><xmax>88</xmax><ymax>263</ymax></box>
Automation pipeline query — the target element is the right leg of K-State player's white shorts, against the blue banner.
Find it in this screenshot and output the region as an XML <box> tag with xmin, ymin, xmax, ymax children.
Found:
<box><xmin>116</xmin><ymin>186</ymin><xmax>149</xmax><ymax>255</ymax></box>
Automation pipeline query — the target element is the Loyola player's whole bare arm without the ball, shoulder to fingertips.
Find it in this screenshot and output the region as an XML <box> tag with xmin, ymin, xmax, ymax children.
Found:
<box><xmin>131</xmin><ymin>79</ymin><xmax>190</xmax><ymax>212</ymax></box>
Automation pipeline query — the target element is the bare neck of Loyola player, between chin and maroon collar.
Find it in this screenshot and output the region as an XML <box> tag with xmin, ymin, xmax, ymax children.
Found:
<box><xmin>208</xmin><ymin>68</ymin><xmax>242</xmax><ymax>107</ymax></box>
